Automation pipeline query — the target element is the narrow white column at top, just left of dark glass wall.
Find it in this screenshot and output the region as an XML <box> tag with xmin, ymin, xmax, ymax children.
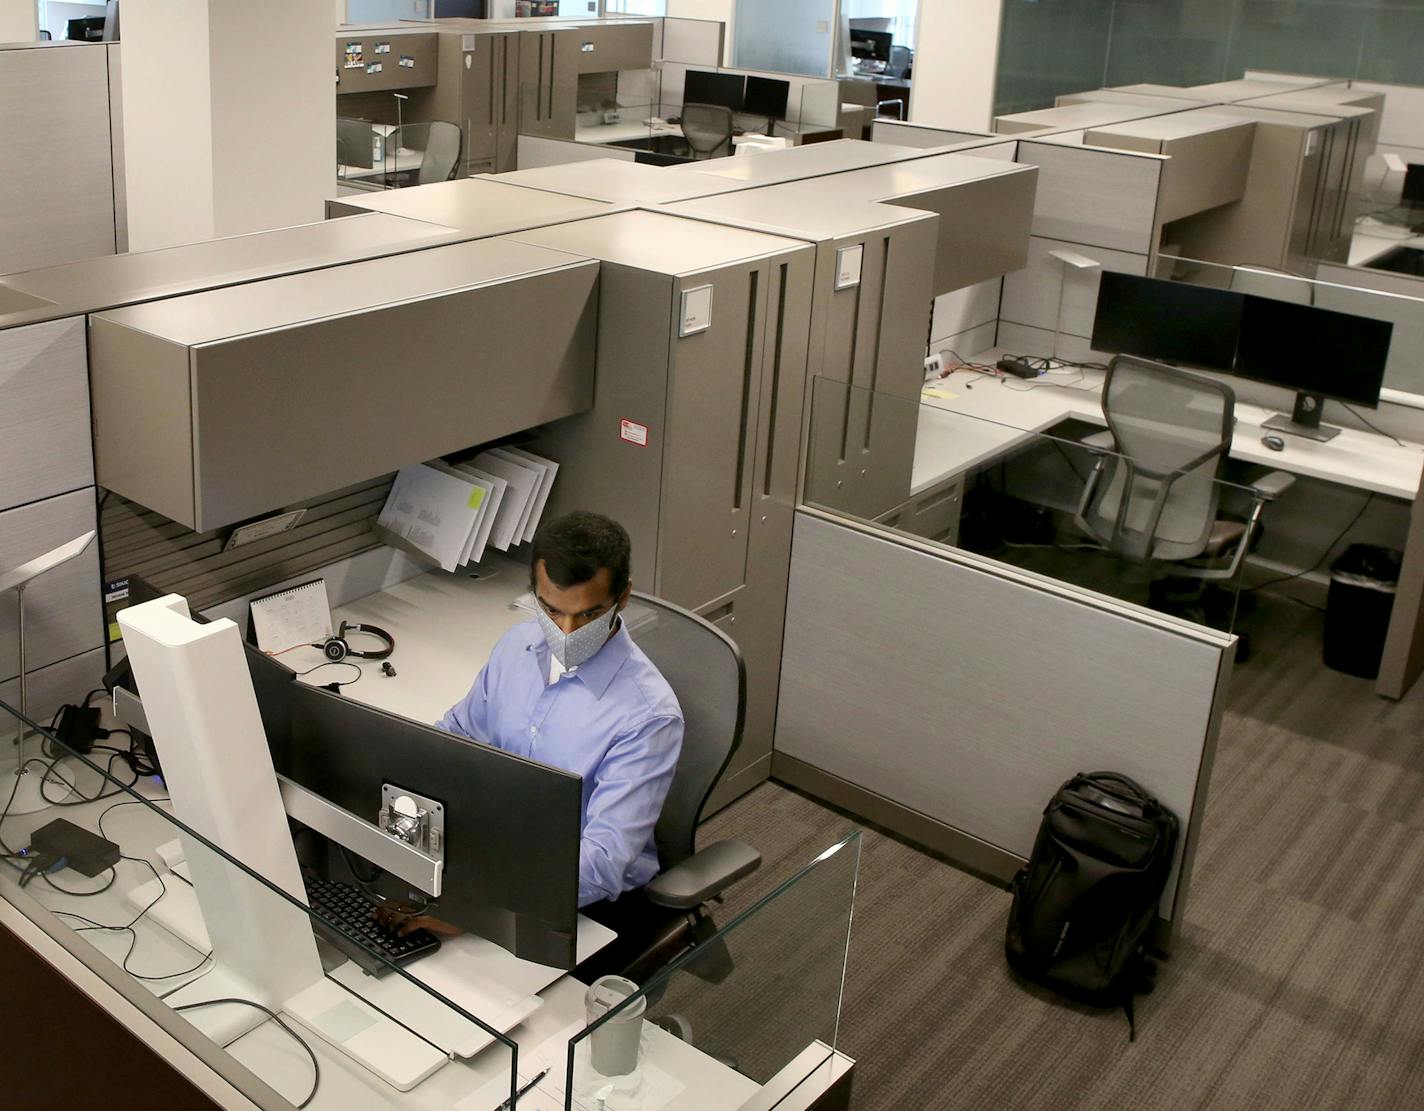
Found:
<box><xmin>910</xmin><ymin>0</ymin><xmax>1004</xmax><ymax>131</ymax></box>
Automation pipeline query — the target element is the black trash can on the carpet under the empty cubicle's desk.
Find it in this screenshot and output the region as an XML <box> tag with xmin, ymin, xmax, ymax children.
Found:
<box><xmin>1324</xmin><ymin>544</ymin><xmax>1404</xmax><ymax>679</ymax></box>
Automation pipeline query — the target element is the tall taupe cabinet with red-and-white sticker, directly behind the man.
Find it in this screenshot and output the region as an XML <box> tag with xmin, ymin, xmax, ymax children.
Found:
<box><xmin>511</xmin><ymin>212</ymin><xmax>816</xmax><ymax>806</ymax></box>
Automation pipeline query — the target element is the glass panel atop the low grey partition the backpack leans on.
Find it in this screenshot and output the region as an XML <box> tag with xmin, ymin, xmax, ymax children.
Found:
<box><xmin>805</xmin><ymin>366</ymin><xmax>1264</xmax><ymax>631</ymax></box>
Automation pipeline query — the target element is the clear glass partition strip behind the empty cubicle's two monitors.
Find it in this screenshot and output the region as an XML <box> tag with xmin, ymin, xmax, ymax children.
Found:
<box><xmin>1152</xmin><ymin>255</ymin><xmax>1424</xmax><ymax>401</ymax></box>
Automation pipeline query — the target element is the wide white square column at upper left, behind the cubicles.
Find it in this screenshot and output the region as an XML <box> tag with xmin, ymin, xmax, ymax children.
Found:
<box><xmin>121</xmin><ymin>0</ymin><xmax>336</xmax><ymax>251</ymax></box>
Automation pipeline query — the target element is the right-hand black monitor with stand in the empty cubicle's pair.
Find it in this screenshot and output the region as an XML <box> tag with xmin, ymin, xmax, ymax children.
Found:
<box><xmin>1235</xmin><ymin>296</ymin><xmax>1394</xmax><ymax>439</ymax></box>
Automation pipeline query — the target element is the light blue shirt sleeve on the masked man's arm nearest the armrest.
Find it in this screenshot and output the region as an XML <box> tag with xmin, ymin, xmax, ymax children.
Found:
<box><xmin>580</xmin><ymin>715</ymin><xmax>682</xmax><ymax>906</ymax></box>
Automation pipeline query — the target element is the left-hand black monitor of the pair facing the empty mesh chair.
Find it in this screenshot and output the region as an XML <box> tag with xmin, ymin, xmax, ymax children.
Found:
<box><xmin>1091</xmin><ymin>271</ymin><xmax>1243</xmax><ymax>370</ymax></box>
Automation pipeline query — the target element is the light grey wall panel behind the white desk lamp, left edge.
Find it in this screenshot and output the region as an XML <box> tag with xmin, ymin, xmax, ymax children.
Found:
<box><xmin>0</xmin><ymin>487</ymin><xmax>103</xmax><ymax>679</ymax></box>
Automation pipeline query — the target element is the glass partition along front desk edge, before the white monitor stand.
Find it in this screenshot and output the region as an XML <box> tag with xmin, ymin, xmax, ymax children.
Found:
<box><xmin>0</xmin><ymin>692</ymin><xmax>517</xmax><ymax>1111</ymax></box>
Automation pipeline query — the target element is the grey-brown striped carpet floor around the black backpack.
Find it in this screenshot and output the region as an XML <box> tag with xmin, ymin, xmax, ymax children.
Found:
<box><xmin>701</xmin><ymin>600</ymin><xmax>1424</xmax><ymax>1111</ymax></box>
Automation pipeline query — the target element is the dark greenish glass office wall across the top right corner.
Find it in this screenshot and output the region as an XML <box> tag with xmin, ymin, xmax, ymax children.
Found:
<box><xmin>994</xmin><ymin>0</ymin><xmax>1424</xmax><ymax>115</ymax></box>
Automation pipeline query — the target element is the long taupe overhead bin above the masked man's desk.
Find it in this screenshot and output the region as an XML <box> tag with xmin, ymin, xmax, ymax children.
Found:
<box><xmin>90</xmin><ymin>239</ymin><xmax>598</xmax><ymax>531</ymax></box>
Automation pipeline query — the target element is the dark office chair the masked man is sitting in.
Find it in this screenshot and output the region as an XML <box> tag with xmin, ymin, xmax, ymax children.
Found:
<box><xmin>605</xmin><ymin>593</ymin><xmax>762</xmax><ymax>984</ymax></box>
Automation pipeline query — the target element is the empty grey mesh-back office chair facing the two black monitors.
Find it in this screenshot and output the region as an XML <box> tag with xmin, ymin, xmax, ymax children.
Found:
<box><xmin>1074</xmin><ymin>355</ymin><xmax>1294</xmax><ymax>615</ymax></box>
